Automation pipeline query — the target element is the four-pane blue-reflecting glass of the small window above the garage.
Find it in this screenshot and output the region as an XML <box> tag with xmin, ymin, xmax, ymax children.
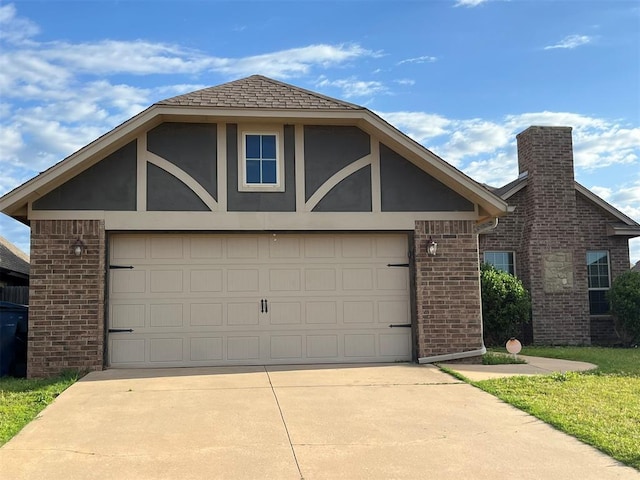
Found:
<box><xmin>244</xmin><ymin>133</ymin><xmax>279</xmax><ymax>185</ymax></box>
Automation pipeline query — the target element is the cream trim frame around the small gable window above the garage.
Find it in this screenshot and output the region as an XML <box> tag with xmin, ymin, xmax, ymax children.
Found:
<box><xmin>238</xmin><ymin>125</ymin><xmax>284</xmax><ymax>192</ymax></box>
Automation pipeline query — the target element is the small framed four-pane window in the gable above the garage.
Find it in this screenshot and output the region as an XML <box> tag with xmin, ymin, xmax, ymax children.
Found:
<box><xmin>238</xmin><ymin>131</ymin><xmax>284</xmax><ymax>191</ymax></box>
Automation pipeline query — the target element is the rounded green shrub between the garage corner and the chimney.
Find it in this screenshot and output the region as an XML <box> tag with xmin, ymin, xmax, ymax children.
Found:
<box><xmin>480</xmin><ymin>264</ymin><xmax>531</xmax><ymax>346</ymax></box>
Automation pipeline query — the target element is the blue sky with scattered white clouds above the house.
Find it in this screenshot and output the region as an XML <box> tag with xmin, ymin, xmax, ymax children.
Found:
<box><xmin>0</xmin><ymin>0</ymin><xmax>640</xmax><ymax>262</ymax></box>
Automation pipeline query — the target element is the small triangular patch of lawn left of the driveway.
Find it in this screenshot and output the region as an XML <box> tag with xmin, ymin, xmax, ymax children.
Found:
<box><xmin>0</xmin><ymin>373</ymin><xmax>79</xmax><ymax>445</ymax></box>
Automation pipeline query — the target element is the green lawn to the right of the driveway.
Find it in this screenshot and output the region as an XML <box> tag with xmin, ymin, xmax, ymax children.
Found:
<box><xmin>473</xmin><ymin>347</ymin><xmax>640</xmax><ymax>470</ymax></box>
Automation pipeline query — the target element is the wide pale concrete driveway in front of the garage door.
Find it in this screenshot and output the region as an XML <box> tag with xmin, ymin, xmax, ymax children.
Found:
<box><xmin>0</xmin><ymin>364</ymin><xmax>640</xmax><ymax>480</ymax></box>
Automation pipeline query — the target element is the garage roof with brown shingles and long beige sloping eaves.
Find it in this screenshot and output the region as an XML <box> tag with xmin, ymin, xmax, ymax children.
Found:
<box><xmin>0</xmin><ymin>75</ymin><xmax>509</xmax><ymax>224</ymax></box>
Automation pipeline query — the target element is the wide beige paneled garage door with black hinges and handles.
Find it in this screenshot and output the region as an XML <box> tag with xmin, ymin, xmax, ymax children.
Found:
<box><xmin>108</xmin><ymin>234</ymin><xmax>411</xmax><ymax>367</ymax></box>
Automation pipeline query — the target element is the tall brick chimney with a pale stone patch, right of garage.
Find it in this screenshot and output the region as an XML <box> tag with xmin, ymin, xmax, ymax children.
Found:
<box><xmin>516</xmin><ymin>126</ymin><xmax>590</xmax><ymax>345</ymax></box>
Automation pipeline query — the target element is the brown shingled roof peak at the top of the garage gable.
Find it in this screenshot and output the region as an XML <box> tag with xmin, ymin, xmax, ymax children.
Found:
<box><xmin>156</xmin><ymin>75</ymin><xmax>364</xmax><ymax>110</ymax></box>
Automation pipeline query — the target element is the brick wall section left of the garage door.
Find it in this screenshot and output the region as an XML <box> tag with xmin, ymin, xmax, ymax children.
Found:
<box><xmin>27</xmin><ymin>220</ymin><xmax>105</xmax><ymax>378</ymax></box>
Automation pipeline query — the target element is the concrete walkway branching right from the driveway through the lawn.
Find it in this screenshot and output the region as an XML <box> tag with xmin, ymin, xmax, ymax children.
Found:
<box><xmin>441</xmin><ymin>355</ymin><xmax>598</xmax><ymax>381</ymax></box>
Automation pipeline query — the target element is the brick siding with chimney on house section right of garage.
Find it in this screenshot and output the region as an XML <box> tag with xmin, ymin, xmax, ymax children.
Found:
<box><xmin>479</xmin><ymin>127</ymin><xmax>629</xmax><ymax>344</ymax></box>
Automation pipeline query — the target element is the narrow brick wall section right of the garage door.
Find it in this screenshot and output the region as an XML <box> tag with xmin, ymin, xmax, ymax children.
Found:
<box><xmin>414</xmin><ymin>221</ymin><xmax>483</xmax><ymax>357</ymax></box>
